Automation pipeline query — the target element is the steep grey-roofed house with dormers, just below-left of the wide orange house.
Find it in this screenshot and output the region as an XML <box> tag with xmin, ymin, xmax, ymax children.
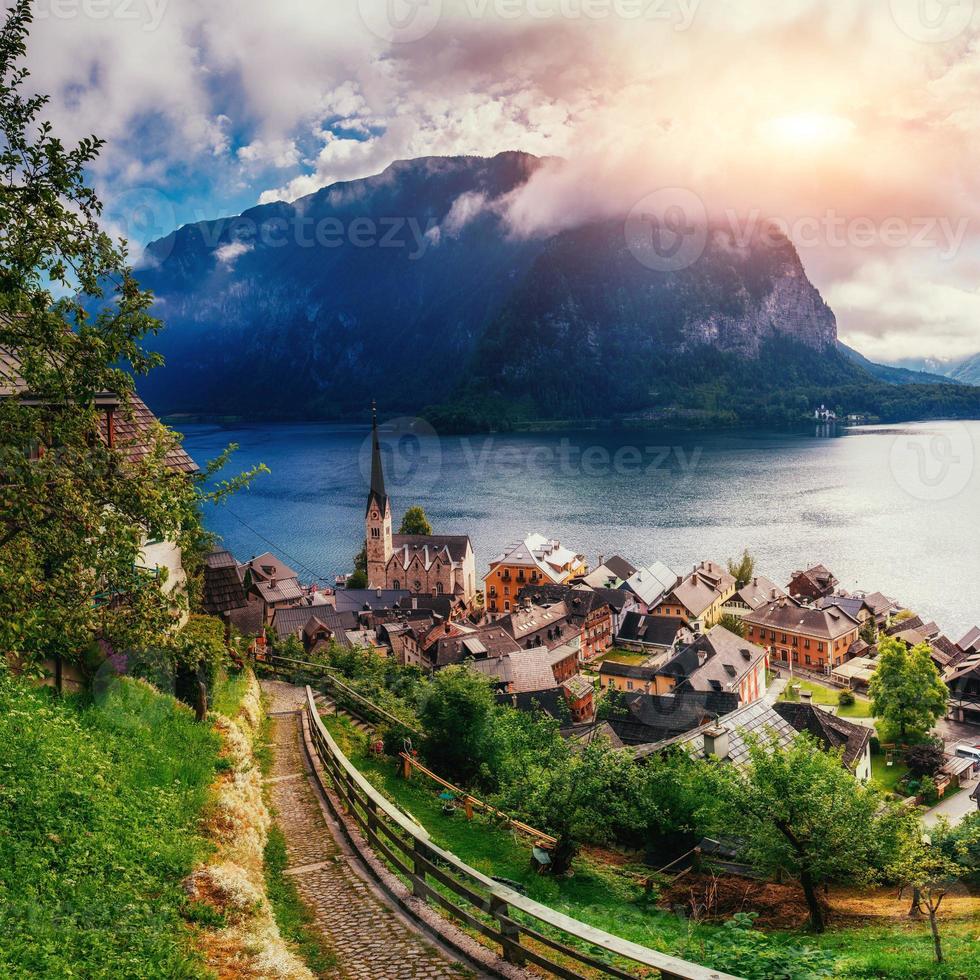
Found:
<box><xmin>655</xmin><ymin>626</ymin><xmax>768</xmax><ymax>704</ymax></box>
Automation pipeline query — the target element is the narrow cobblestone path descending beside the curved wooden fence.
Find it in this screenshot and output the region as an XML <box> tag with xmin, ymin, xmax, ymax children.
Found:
<box><xmin>262</xmin><ymin>681</ymin><xmax>473</xmax><ymax>980</ymax></box>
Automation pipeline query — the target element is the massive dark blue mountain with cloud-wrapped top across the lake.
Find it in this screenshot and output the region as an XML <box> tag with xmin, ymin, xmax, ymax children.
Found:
<box><xmin>128</xmin><ymin>152</ymin><xmax>980</xmax><ymax>427</ymax></box>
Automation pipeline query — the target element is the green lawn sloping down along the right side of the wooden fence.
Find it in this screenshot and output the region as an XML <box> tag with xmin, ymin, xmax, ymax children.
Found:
<box><xmin>324</xmin><ymin>715</ymin><xmax>980</xmax><ymax>980</ymax></box>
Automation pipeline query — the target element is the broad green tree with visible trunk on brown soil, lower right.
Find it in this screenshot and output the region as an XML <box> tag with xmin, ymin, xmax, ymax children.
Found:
<box><xmin>715</xmin><ymin>734</ymin><xmax>889</xmax><ymax>932</ymax></box>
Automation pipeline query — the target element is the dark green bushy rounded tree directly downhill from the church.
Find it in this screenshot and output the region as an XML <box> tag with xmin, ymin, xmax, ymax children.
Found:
<box><xmin>419</xmin><ymin>665</ymin><xmax>498</xmax><ymax>786</ymax></box>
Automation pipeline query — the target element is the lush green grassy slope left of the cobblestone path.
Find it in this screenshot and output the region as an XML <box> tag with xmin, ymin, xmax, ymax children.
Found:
<box><xmin>0</xmin><ymin>672</ymin><xmax>220</xmax><ymax>978</ymax></box>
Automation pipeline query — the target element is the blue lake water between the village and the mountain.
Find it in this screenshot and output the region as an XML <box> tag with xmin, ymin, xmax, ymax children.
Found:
<box><xmin>184</xmin><ymin>422</ymin><xmax>980</xmax><ymax>640</ymax></box>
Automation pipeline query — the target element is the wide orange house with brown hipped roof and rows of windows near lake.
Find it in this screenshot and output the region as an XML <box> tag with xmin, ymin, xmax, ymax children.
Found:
<box><xmin>742</xmin><ymin>597</ymin><xmax>860</xmax><ymax>673</ymax></box>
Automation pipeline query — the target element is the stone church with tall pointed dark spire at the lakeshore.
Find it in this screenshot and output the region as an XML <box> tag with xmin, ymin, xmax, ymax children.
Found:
<box><xmin>364</xmin><ymin>404</ymin><xmax>476</xmax><ymax>608</ymax></box>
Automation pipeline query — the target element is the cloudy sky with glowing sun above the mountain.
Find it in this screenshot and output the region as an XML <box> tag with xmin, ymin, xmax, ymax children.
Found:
<box><xmin>21</xmin><ymin>0</ymin><xmax>980</xmax><ymax>355</ymax></box>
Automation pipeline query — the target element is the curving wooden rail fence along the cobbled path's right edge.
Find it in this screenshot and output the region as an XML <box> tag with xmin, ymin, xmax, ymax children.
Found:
<box><xmin>306</xmin><ymin>686</ymin><xmax>737</xmax><ymax>980</ymax></box>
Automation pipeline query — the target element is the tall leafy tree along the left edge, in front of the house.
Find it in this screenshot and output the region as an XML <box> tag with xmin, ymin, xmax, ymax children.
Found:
<box><xmin>0</xmin><ymin>0</ymin><xmax>260</xmax><ymax>668</ymax></box>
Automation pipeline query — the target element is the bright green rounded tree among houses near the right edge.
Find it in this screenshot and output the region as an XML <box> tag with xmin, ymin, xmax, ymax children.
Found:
<box><xmin>868</xmin><ymin>636</ymin><xmax>949</xmax><ymax>743</ymax></box>
